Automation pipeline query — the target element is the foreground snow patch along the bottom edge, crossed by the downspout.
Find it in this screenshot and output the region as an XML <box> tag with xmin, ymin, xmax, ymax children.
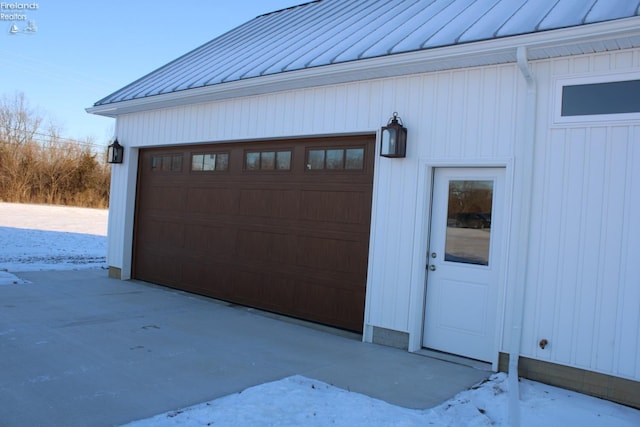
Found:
<box><xmin>127</xmin><ymin>373</ymin><xmax>640</xmax><ymax>427</ymax></box>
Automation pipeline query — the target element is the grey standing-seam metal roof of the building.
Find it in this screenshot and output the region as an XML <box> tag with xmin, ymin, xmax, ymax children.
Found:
<box><xmin>94</xmin><ymin>0</ymin><xmax>640</xmax><ymax>106</ymax></box>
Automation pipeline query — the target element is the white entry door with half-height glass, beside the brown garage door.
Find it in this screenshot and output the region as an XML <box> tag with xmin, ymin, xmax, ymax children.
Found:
<box><xmin>423</xmin><ymin>168</ymin><xmax>504</xmax><ymax>362</ymax></box>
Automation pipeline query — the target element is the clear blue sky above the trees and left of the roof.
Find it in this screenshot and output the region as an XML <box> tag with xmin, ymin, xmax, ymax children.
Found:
<box><xmin>0</xmin><ymin>0</ymin><xmax>307</xmax><ymax>145</ymax></box>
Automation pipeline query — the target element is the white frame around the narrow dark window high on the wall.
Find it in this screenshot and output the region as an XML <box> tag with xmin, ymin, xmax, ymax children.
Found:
<box><xmin>553</xmin><ymin>71</ymin><xmax>640</xmax><ymax>125</ymax></box>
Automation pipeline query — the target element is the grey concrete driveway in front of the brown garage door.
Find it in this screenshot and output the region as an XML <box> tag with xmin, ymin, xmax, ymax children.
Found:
<box><xmin>0</xmin><ymin>270</ymin><xmax>490</xmax><ymax>427</ymax></box>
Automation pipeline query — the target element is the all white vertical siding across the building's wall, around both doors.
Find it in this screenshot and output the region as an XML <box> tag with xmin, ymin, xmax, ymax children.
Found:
<box><xmin>109</xmin><ymin>45</ymin><xmax>640</xmax><ymax>379</ymax></box>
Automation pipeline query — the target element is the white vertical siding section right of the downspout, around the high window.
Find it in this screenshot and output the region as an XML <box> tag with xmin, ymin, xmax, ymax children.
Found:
<box><xmin>522</xmin><ymin>49</ymin><xmax>640</xmax><ymax>379</ymax></box>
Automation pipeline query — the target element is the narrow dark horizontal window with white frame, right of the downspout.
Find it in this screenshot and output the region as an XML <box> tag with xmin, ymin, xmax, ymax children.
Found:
<box><xmin>556</xmin><ymin>75</ymin><xmax>640</xmax><ymax>123</ymax></box>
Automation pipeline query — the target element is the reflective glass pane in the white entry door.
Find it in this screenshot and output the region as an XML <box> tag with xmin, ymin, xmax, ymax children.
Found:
<box><xmin>444</xmin><ymin>180</ymin><xmax>493</xmax><ymax>265</ymax></box>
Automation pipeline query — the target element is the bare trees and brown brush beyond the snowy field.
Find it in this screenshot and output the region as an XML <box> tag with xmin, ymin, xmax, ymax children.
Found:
<box><xmin>0</xmin><ymin>94</ymin><xmax>110</xmax><ymax>207</ymax></box>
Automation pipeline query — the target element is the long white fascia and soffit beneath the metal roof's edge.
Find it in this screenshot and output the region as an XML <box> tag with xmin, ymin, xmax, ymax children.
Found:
<box><xmin>86</xmin><ymin>17</ymin><xmax>640</xmax><ymax>117</ymax></box>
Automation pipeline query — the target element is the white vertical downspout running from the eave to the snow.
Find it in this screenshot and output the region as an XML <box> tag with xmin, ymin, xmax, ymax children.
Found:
<box><xmin>508</xmin><ymin>46</ymin><xmax>537</xmax><ymax>427</ymax></box>
